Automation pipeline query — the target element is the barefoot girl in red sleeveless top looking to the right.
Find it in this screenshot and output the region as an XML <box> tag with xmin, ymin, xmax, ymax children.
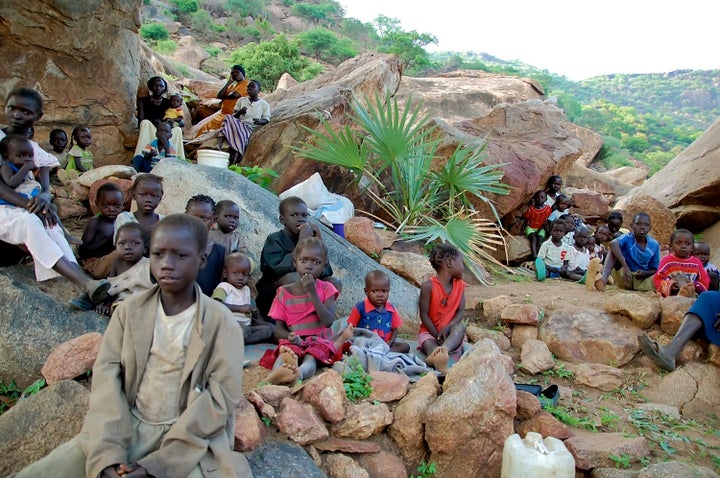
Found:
<box><xmin>418</xmin><ymin>243</ymin><xmax>465</xmax><ymax>373</ymax></box>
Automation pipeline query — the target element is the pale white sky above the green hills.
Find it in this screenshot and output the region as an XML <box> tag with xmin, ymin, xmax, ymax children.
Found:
<box><xmin>338</xmin><ymin>0</ymin><xmax>720</xmax><ymax>81</ymax></box>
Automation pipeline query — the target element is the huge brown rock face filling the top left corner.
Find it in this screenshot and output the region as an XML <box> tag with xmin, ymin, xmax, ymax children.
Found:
<box><xmin>0</xmin><ymin>0</ymin><xmax>145</xmax><ymax>164</ymax></box>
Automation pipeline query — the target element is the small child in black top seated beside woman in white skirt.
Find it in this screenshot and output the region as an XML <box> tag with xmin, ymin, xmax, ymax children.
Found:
<box><xmin>78</xmin><ymin>182</ymin><xmax>124</xmax><ymax>279</ymax></box>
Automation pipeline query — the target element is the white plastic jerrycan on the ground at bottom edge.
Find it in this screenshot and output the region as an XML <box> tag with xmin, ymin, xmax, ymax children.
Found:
<box><xmin>500</xmin><ymin>432</ymin><xmax>575</xmax><ymax>478</ymax></box>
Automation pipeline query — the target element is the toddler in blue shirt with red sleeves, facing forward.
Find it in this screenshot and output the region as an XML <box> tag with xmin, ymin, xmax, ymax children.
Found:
<box><xmin>348</xmin><ymin>270</ymin><xmax>410</xmax><ymax>354</ymax></box>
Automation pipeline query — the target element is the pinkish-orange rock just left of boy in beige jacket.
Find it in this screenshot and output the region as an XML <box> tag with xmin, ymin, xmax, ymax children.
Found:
<box><xmin>40</xmin><ymin>332</ymin><xmax>102</xmax><ymax>385</ymax></box>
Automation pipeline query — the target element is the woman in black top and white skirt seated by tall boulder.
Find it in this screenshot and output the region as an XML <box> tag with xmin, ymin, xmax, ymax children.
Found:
<box><xmin>135</xmin><ymin>76</ymin><xmax>185</xmax><ymax>159</ymax></box>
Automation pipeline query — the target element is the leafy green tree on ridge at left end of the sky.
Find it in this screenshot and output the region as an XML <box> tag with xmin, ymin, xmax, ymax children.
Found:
<box><xmin>375</xmin><ymin>15</ymin><xmax>437</xmax><ymax>72</ymax></box>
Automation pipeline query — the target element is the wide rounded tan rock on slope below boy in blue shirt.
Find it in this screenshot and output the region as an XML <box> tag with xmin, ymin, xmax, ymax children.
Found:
<box><xmin>538</xmin><ymin>308</ymin><xmax>641</xmax><ymax>366</ymax></box>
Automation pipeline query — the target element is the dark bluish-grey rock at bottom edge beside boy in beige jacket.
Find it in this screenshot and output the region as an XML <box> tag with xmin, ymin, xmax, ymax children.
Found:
<box><xmin>247</xmin><ymin>441</ymin><xmax>326</xmax><ymax>478</ymax></box>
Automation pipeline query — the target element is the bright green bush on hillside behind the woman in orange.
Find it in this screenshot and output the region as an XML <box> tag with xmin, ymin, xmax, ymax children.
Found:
<box><xmin>229</xmin><ymin>33</ymin><xmax>322</xmax><ymax>91</ymax></box>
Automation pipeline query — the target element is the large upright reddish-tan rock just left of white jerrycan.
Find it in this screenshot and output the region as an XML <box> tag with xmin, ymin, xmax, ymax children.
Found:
<box><xmin>424</xmin><ymin>340</ymin><xmax>516</xmax><ymax>478</ymax></box>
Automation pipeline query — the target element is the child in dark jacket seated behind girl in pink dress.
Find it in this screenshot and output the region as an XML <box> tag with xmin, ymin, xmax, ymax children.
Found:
<box><xmin>257</xmin><ymin>196</ymin><xmax>342</xmax><ymax>317</ymax></box>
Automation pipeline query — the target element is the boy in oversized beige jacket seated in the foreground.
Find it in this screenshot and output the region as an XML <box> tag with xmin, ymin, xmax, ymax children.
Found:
<box><xmin>11</xmin><ymin>214</ymin><xmax>252</xmax><ymax>478</ymax></box>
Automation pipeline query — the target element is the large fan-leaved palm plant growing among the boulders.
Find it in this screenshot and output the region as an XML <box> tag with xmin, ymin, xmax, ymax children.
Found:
<box><xmin>295</xmin><ymin>95</ymin><xmax>509</xmax><ymax>277</ymax></box>
